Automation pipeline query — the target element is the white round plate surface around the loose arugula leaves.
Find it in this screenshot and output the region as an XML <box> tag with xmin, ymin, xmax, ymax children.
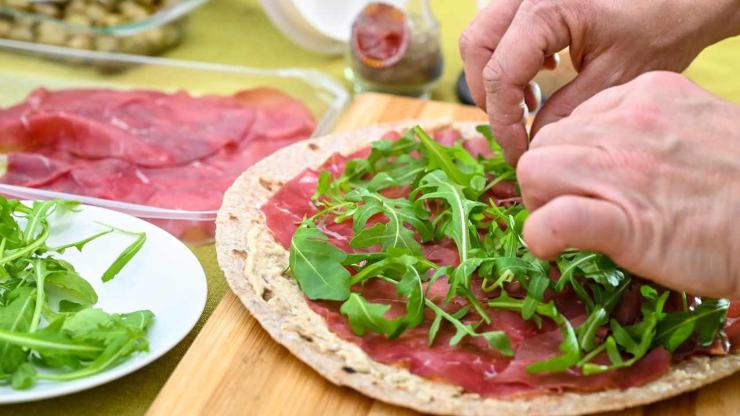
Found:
<box><xmin>0</xmin><ymin>206</ymin><xmax>207</xmax><ymax>403</ymax></box>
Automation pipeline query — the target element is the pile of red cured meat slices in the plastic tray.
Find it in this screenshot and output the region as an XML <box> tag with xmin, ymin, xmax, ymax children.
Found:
<box><xmin>0</xmin><ymin>88</ymin><xmax>316</xmax><ymax>239</ymax></box>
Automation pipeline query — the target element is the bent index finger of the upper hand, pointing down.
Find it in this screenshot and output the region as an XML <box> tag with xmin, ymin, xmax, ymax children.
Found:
<box><xmin>483</xmin><ymin>0</ymin><xmax>570</xmax><ymax>165</ymax></box>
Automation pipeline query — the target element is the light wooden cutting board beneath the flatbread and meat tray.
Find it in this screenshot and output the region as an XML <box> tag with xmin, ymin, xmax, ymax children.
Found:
<box><xmin>148</xmin><ymin>94</ymin><xmax>740</xmax><ymax>416</ymax></box>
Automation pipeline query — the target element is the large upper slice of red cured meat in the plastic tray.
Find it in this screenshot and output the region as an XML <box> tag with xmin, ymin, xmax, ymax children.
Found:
<box><xmin>0</xmin><ymin>89</ymin><xmax>255</xmax><ymax>166</ymax></box>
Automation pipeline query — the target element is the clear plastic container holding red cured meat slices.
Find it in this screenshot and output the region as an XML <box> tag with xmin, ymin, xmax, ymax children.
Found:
<box><xmin>0</xmin><ymin>39</ymin><xmax>348</xmax><ymax>243</ymax></box>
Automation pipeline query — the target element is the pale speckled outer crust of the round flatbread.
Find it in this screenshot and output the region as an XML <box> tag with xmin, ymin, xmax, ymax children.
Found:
<box><xmin>216</xmin><ymin>121</ymin><xmax>740</xmax><ymax>416</ymax></box>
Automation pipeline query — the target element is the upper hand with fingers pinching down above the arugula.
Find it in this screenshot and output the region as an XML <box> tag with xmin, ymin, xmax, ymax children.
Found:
<box><xmin>460</xmin><ymin>0</ymin><xmax>740</xmax><ymax>164</ymax></box>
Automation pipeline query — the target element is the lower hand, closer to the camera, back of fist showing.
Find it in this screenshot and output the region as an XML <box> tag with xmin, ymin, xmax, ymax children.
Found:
<box><xmin>517</xmin><ymin>72</ymin><xmax>740</xmax><ymax>298</ymax></box>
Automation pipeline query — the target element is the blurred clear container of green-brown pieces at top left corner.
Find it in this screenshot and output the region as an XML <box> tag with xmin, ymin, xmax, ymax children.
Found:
<box><xmin>0</xmin><ymin>0</ymin><xmax>207</xmax><ymax>55</ymax></box>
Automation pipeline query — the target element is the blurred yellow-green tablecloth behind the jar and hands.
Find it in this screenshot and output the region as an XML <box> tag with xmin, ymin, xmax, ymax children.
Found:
<box><xmin>158</xmin><ymin>0</ymin><xmax>740</xmax><ymax>101</ymax></box>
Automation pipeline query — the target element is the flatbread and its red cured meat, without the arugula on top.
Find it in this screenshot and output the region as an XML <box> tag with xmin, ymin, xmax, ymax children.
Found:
<box><xmin>216</xmin><ymin>123</ymin><xmax>740</xmax><ymax>414</ymax></box>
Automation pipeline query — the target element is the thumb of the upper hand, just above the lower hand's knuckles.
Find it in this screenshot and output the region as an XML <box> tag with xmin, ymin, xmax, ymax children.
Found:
<box><xmin>532</xmin><ymin>65</ymin><xmax>609</xmax><ymax>137</ymax></box>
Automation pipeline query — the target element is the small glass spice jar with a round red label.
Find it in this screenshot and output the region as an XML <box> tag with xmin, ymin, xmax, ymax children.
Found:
<box><xmin>345</xmin><ymin>0</ymin><xmax>443</xmax><ymax>98</ymax></box>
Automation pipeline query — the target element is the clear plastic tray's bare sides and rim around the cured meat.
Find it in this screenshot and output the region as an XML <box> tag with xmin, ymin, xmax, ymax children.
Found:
<box><xmin>0</xmin><ymin>39</ymin><xmax>349</xmax><ymax>243</ymax></box>
